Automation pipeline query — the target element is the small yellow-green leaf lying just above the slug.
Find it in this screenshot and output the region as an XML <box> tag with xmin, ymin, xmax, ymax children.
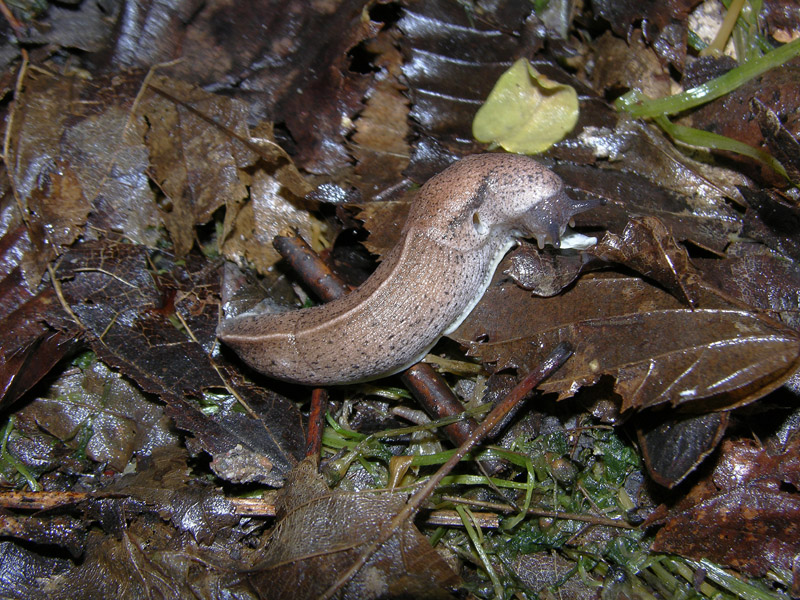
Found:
<box><xmin>472</xmin><ymin>58</ymin><xmax>578</xmax><ymax>154</ymax></box>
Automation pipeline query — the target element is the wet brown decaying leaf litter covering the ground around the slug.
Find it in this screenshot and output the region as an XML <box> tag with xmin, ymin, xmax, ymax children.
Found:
<box><xmin>0</xmin><ymin>1</ymin><xmax>800</xmax><ymax>598</ymax></box>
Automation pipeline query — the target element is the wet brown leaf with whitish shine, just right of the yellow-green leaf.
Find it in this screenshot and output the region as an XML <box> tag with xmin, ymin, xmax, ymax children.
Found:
<box><xmin>553</xmin><ymin>117</ymin><xmax>748</xmax><ymax>254</ymax></box>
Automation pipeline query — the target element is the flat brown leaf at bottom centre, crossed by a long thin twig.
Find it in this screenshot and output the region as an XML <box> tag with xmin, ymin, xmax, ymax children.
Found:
<box><xmin>250</xmin><ymin>459</ymin><xmax>460</xmax><ymax>600</ymax></box>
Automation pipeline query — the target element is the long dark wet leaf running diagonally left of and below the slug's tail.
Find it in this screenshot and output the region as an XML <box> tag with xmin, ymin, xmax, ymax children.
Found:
<box><xmin>49</xmin><ymin>242</ymin><xmax>304</xmax><ymax>485</ymax></box>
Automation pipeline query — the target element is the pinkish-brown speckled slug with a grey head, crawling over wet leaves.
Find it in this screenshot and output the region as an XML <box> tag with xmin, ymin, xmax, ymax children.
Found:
<box><xmin>217</xmin><ymin>154</ymin><xmax>595</xmax><ymax>385</ymax></box>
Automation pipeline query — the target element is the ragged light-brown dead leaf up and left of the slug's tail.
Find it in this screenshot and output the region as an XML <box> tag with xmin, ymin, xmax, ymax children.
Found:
<box><xmin>136</xmin><ymin>77</ymin><xmax>311</xmax><ymax>262</ymax></box>
